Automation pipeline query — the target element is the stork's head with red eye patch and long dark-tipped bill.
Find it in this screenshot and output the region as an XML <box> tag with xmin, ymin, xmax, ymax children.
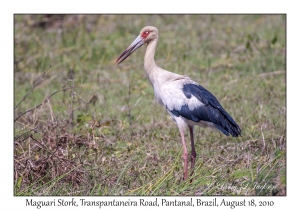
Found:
<box><xmin>116</xmin><ymin>26</ymin><xmax>158</xmax><ymax>64</ymax></box>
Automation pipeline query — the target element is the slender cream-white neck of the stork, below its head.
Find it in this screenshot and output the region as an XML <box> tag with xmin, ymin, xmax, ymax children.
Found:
<box><xmin>144</xmin><ymin>39</ymin><xmax>160</xmax><ymax>86</ymax></box>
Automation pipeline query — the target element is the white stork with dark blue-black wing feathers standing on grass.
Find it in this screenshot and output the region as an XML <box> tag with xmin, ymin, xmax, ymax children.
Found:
<box><xmin>116</xmin><ymin>26</ymin><xmax>241</xmax><ymax>180</ymax></box>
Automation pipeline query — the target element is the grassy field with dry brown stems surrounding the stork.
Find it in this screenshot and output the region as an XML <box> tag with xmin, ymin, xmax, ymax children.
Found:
<box><xmin>14</xmin><ymin>15</ymin><xmax>286</xmax><ymax>196</ymax></box>
